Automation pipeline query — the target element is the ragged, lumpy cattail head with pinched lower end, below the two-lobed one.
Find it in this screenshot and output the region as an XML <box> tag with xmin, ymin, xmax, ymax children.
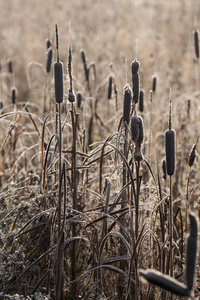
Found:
<box><xmin>130</xmin><ymin>115</ymin><xmax>144</xmax><ymax>161</ymax></box>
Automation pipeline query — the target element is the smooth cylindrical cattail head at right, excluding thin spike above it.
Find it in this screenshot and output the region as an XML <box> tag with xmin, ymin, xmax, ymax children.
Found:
<box><xmin>165</xmin><ymin>129</ymin><xmax>175</xmax><ymax>176</ymax></box>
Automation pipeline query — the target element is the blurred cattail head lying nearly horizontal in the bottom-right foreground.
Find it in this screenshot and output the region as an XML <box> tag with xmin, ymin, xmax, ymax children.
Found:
<box><xmin>139</xmin><ymin>269</ymin><xmax>191</xmax><ymax>297</ymax></box>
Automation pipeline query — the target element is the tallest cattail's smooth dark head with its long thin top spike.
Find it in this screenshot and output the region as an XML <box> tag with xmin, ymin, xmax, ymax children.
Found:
<box><xmin>54</xmin><ymin>24</ymin><xmax>63</xmax><ymax>103</ymax></box>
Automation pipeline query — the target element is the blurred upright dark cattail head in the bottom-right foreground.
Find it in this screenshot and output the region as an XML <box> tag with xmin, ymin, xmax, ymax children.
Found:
<box><xmin>185</xmin><ymin>213</ymin><xmax>198</xmax><ymax>290</ymax></box>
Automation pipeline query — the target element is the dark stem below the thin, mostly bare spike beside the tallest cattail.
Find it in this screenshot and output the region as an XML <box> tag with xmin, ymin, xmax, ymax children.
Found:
<box><xmin>70</xmin><ymin>103</ymin><xmax>78</xmax><ymax>299</ymax></box>
